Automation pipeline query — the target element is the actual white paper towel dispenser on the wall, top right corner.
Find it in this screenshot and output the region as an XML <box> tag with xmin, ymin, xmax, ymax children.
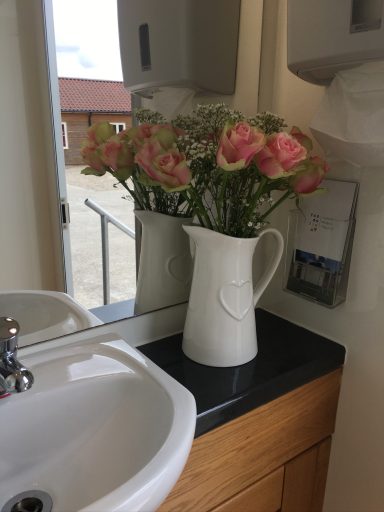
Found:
<box><xmin>288</xmin><ymin>0</ymin><xmax>384</xmax><ymax>85</ymax></box>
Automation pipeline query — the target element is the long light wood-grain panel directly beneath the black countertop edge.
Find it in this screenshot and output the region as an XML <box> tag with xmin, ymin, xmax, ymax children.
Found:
<box><xmin>159</xmin><ymin>369</ymin><xmax>341</xmax><ymax>512</ymax></box>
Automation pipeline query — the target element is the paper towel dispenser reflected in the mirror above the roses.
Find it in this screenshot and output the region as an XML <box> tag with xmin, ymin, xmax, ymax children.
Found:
<box><xmin>118</xmin><ymin>0</ymin><xmax>241</xmax><ymax>97</ymax></box>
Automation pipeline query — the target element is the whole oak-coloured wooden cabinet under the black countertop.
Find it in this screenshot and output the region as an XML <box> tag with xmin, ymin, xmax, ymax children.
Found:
<box><xmin>159</xmin><ymin>369</ymin><xmax>341</xmax><ymax>512</ymax></box>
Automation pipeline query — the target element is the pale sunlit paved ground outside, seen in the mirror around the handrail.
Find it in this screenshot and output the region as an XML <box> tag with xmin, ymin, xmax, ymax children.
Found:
<box><xmin>66</xmin><ymin>166</ymin><xmax>136</xmax><ymax>308</ymax></box>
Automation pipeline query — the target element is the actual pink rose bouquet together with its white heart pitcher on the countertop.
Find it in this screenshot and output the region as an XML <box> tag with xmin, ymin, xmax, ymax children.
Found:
<box><xmin>166</xmin><ymin>104</ymin><xmax>328</xmax><ymax>367</ymax></box>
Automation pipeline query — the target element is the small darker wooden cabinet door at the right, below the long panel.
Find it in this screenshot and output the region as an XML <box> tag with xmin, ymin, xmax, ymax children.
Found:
<box><xmin>281</xmin><ymin>437</ymin><xmax>331</xmax><ymax>512</ymax></box>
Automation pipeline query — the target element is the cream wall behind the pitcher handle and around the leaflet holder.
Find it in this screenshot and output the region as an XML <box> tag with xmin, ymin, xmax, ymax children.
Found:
<box><xmin>260</xmin><ymin>0</ymin><xmax>384</xmax><ymax>512</ymax></box>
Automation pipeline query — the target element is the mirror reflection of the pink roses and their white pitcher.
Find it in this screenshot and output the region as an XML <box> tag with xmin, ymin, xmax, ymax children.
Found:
<box><xmin>82</xmin><ymin>111</ymin><xmax>192</xmax><ymax>314</ymax></box>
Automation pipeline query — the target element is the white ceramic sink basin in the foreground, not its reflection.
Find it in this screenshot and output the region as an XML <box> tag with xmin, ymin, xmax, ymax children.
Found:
<box><xmin>0</xmin><ymin>331</ymin><xmax>196</xmax><ymax>512</ymax></box>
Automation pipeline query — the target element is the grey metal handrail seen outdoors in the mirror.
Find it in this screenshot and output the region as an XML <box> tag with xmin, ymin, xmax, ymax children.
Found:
<box><xmin>84</xmin><ymin>199</ymin><xmax>135</xmax><ymax>305</ymax></box>
